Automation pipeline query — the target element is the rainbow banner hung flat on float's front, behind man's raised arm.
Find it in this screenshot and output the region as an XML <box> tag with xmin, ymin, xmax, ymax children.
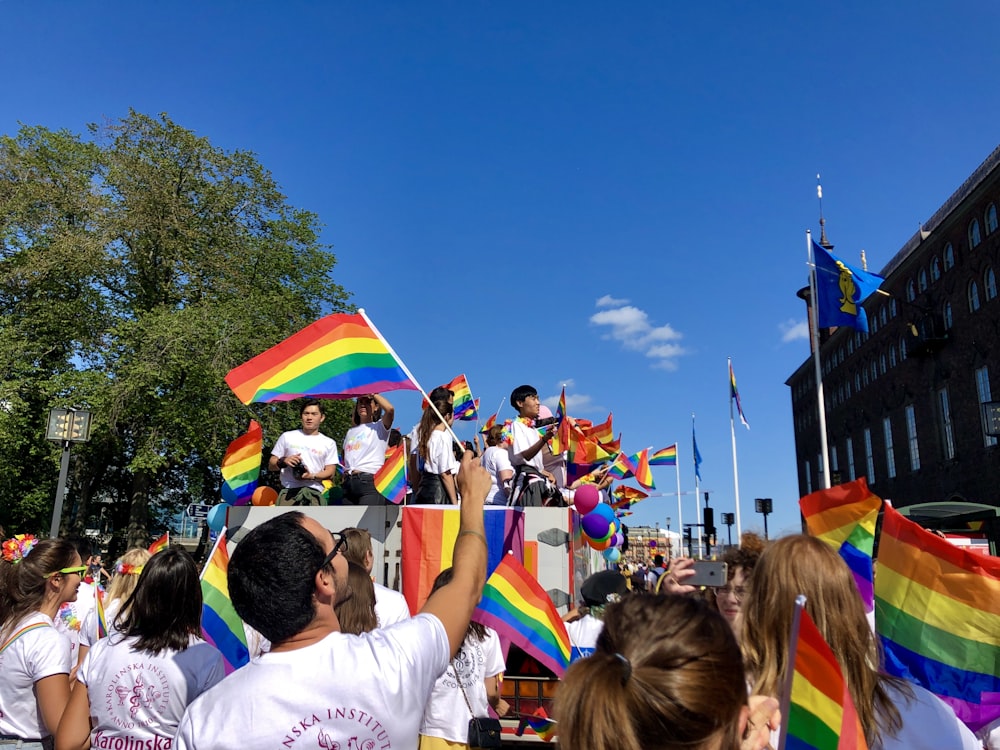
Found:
<box><xmin>401</xmin><ymin>505</ymin><xmax>524</xmax><ymax>614</ymax></box>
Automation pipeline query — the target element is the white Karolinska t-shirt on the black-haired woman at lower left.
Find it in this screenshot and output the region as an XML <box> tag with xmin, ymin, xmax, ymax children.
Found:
<box><xmin>77</xmin><ymin>634</ymin><xmax>226</xmax><ymax>748</ymax></box>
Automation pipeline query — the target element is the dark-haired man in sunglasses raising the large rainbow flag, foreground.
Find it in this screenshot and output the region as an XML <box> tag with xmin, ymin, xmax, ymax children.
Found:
<box><xmin>173</xmin><ymin>452</ymin><xmax>490</xmax><ymax>750</ymax></box>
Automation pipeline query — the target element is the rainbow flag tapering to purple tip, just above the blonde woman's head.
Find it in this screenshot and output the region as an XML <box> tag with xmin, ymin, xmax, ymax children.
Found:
<box><xmin>799</xmin><ymin>477</ymin><xmax>882</xmax><ymax>612</ymax></box>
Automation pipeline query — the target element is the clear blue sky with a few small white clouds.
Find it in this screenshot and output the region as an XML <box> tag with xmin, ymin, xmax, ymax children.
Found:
<box><xmin>7</xmin><ymin>0</ymin><xmax>1000</xmax><ymax>535</ymax></box>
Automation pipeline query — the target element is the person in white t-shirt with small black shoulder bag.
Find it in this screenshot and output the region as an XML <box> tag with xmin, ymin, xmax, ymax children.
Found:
<box><xmin>420</xmin><ymin>568</ymin><xmax>506</xmax><ymax>750</ymax></box>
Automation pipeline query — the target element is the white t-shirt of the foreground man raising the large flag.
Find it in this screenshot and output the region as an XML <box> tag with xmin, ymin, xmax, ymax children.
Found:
<box><xmin>174</xmin><ymin>614</ymin><xmax>451</xmax><ymax>750</ymax></box>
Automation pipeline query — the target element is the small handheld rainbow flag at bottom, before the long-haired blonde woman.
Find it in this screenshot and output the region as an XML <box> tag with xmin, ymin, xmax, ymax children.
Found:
<box><xmin>779</xmin><ymin>597</ymin><xmax>868</xmax><ymax>750</ymax></box>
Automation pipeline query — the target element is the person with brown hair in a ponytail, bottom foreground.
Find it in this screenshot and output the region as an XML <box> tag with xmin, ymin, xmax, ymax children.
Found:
<box><xmin>553</xmin><ymin>594</ymin><xmax>777</xmax><ymax>750</ymax></box>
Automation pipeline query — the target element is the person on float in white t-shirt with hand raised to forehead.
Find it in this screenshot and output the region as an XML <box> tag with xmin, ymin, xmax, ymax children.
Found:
<box><xmin>344</xmin><ymin>393</ymin><xmax>396</xmax><ymax>505</ymax></box>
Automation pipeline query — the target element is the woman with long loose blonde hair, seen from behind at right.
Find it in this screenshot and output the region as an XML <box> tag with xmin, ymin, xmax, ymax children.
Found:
<box><xmin>743</xmin><ymin>535</ymin><xmax>982</xmax><ymax>750</ymax></box>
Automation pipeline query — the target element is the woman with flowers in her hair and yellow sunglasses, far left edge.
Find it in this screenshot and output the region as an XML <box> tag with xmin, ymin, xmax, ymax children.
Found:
<box><xmin>0</xmin><ymin>534</ymin><xmax>81</xmax><ymax>750</ymax></box>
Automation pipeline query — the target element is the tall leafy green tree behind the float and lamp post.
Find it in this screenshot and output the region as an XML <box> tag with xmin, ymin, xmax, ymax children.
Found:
<box><xmin>0</xmin><ymin>112</ymin><xmax>348</xmax><ymax>545</ymax></box>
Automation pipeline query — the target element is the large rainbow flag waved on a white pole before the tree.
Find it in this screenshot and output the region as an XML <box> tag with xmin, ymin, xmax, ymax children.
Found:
<box><xmin>226</xmin><ymin>312</ymin><xmax>417</xmax><ymax>404</ymax></box>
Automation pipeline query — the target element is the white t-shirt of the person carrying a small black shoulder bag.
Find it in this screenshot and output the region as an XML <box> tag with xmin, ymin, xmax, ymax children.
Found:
<box><xmin>420</xmin><ymin>628</ymin><xmax>505</xmax><ymax>742</ymax></box>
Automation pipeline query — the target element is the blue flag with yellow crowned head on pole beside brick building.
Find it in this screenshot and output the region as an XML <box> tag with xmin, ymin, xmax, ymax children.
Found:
<box><xmin>813</xmin><ymin>240</ymin><xmax>884</xmax><ymax>333</ymax></box>
